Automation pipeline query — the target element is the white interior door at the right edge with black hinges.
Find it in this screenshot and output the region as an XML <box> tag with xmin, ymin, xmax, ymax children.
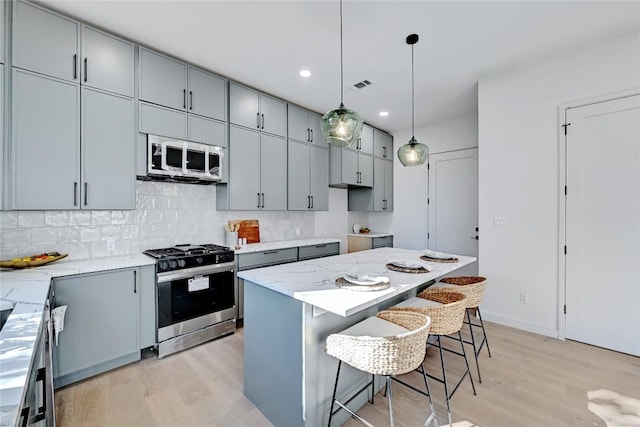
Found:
<box><xmin>565</xmin><ymin>96</ymin><xmax>640</xmax><ymax>356</ymax></box>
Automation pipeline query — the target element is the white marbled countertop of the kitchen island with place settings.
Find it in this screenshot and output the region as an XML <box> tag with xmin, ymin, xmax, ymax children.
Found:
<box><xmin>238</xmin><ymin>248</ymin><xmax>476</xmax><ymax>317</ymax></box>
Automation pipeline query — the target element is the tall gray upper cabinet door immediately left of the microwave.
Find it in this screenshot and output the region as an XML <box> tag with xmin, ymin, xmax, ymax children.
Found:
<box><xmin>80</xmin><ymin>88</ymin><xmax>135</xmax><ymax>209</ymax></box>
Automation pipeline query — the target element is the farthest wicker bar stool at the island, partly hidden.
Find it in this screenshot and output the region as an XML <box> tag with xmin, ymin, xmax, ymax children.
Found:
<box><xmin>431</xmin><ymin>276</ymin><xmax>491</xmax><ymax>382</ymax></box>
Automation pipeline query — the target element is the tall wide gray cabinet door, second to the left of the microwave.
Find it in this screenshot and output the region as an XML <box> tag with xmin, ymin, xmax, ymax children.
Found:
<box><xmin>11</xmin><ymin>68</ymin><xmax>80</xmax><ymax>209</ymax></box>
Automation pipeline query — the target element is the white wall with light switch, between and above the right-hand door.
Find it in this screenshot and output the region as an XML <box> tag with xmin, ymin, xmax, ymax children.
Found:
<box><xmin>478</xmin><ymin>34</ymin><xmax>640</xmax><ymax>336</ymax></box>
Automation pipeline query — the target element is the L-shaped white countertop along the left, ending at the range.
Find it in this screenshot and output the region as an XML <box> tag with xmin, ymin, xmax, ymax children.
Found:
<box><xmin>0</xmin><ymin>254</ymin><xmax>155</xmax><ymax>426</ymax></box>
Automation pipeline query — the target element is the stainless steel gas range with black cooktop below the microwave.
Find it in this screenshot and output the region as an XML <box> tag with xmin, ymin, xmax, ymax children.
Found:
<box><xmin>144</xmin><ymin>244</ymin><xmax>236</xmax><ymax>358</ymax></box>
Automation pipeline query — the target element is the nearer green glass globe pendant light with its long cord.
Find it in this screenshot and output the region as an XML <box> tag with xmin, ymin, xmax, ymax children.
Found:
<box><xmin>320</xmin><ymin>0</ymin><xmax>362</xmax><ymax>147</ymax></box>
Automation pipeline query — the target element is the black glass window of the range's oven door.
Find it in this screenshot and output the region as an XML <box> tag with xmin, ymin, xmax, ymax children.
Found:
<box><xmin>158</xmin><ymin>271</ymin><xmax>235</xmax><ymax>328</ymax></box>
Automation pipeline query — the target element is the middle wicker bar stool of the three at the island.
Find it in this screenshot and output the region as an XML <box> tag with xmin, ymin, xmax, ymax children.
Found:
<box><xmin>389</xmin><ymin>289</ymin><xmax>476</xmax><ymax>425</ymax></box>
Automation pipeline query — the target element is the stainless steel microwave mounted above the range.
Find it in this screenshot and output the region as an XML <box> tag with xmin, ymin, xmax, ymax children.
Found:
<box><xmin>147</xmin><ymin>135</ymin><xmax>224</xmax><ymax>181</ymax></box>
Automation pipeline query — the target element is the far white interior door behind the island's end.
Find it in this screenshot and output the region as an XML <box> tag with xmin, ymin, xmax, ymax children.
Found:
<box><xmin>428</xmin><ymin>148</ymin><xmax>478</xmax><ymax>275</ymax></box>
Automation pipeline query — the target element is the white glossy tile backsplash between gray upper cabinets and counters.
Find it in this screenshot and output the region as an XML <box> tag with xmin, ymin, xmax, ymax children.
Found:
<box><xmin>0</xmin><ymin>181</ymin><xmax>360</xmax><ymax>259</ymax></box>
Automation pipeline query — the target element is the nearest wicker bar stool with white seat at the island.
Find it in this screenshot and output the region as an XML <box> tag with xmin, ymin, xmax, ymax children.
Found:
<box><xmin>326</xmin><ymin>311</ymin><xmax>438</xmax><ymax>427</ymax></box>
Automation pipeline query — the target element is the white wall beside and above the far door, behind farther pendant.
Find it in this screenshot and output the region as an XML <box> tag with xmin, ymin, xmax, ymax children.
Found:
<box><xmin>369</xmin><ymin>113</ymin><xmax>478</xmax><ymax>249</ymax></box>
